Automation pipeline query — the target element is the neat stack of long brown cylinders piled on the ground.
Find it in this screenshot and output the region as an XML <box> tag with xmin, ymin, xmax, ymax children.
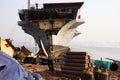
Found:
<box><xmin>61</xmin><ymin>52</ymin><xmax>94</xmax><ymax>80</ymax></box>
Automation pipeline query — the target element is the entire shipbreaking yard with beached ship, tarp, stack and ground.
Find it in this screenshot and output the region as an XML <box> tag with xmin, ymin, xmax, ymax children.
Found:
<box><xmin>0</xmin><ymin>0</ymin><xmax>120</xmax><ymax>80</ymax></box>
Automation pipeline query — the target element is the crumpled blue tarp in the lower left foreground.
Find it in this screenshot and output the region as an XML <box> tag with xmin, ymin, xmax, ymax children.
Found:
<box><xmin>0</xmin><ymin>51</ymin><xmax>43</xmax><ymax>80</ymax></box>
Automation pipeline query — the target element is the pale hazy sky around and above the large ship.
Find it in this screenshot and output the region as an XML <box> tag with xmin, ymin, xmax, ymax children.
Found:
<box><xmin>0</xmin><ymin>0</ymin><xmax>120</xmax><ymax>42</ymax></box>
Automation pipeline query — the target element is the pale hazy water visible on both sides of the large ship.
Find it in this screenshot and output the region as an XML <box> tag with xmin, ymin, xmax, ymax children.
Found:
<box><xmin>13</xmin><ymin>42</ymin><xmax>120</xmax><ymax>61</ymax></box>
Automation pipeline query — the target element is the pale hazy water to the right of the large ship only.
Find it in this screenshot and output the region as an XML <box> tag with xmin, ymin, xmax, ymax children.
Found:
<box><xmin>70</xmin><ymin>44</ymin><xmax>120</xmax><ymax>61</ymax></box>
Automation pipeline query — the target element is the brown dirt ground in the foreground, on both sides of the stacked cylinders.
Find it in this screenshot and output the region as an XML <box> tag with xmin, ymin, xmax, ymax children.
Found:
<box><xmin>22</xmin><ymin>63</ymin><xmax>120</xmax><ymax>80</ymax></box>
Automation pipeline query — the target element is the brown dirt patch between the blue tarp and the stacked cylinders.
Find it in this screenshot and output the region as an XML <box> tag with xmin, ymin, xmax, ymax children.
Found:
<box><xmin>22</xmin><ymin>64</ymin><xmax>68</xmax><ymax>80</ymax></box>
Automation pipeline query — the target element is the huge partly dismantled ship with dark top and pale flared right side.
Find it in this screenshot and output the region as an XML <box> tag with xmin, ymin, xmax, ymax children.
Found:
<box><xmin>18</xmin><ymin>0</ymin><xmax>84</xmax><ymax>58</ymax></box>
